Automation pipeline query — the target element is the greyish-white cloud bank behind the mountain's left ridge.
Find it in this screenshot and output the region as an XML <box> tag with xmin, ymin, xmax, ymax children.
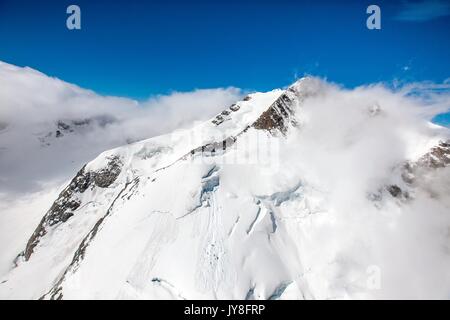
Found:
<box><xmin>0</xmin><ymin>62</ymin><xmax>243</xmax><ymax>195</ymax></box>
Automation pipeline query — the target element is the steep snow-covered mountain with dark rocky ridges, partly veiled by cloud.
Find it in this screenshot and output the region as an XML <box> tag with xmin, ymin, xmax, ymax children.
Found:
<box><xmin>0</xmin><ymin>78</ymin><xmax>450</xmax><ymax>299</ymax></box>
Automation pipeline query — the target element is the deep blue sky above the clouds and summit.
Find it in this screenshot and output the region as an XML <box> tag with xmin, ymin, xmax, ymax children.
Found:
<box><xmin>0</xmin><ymin>0</ymin><xmax>450</xmax><ymax>99</ymax></box>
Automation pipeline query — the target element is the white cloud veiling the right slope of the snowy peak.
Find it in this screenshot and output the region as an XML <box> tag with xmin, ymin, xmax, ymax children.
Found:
<box><xmin>274</xmin><ymin>79</ymin><xmax>450</xmax><ymax>299</ymax></box>
